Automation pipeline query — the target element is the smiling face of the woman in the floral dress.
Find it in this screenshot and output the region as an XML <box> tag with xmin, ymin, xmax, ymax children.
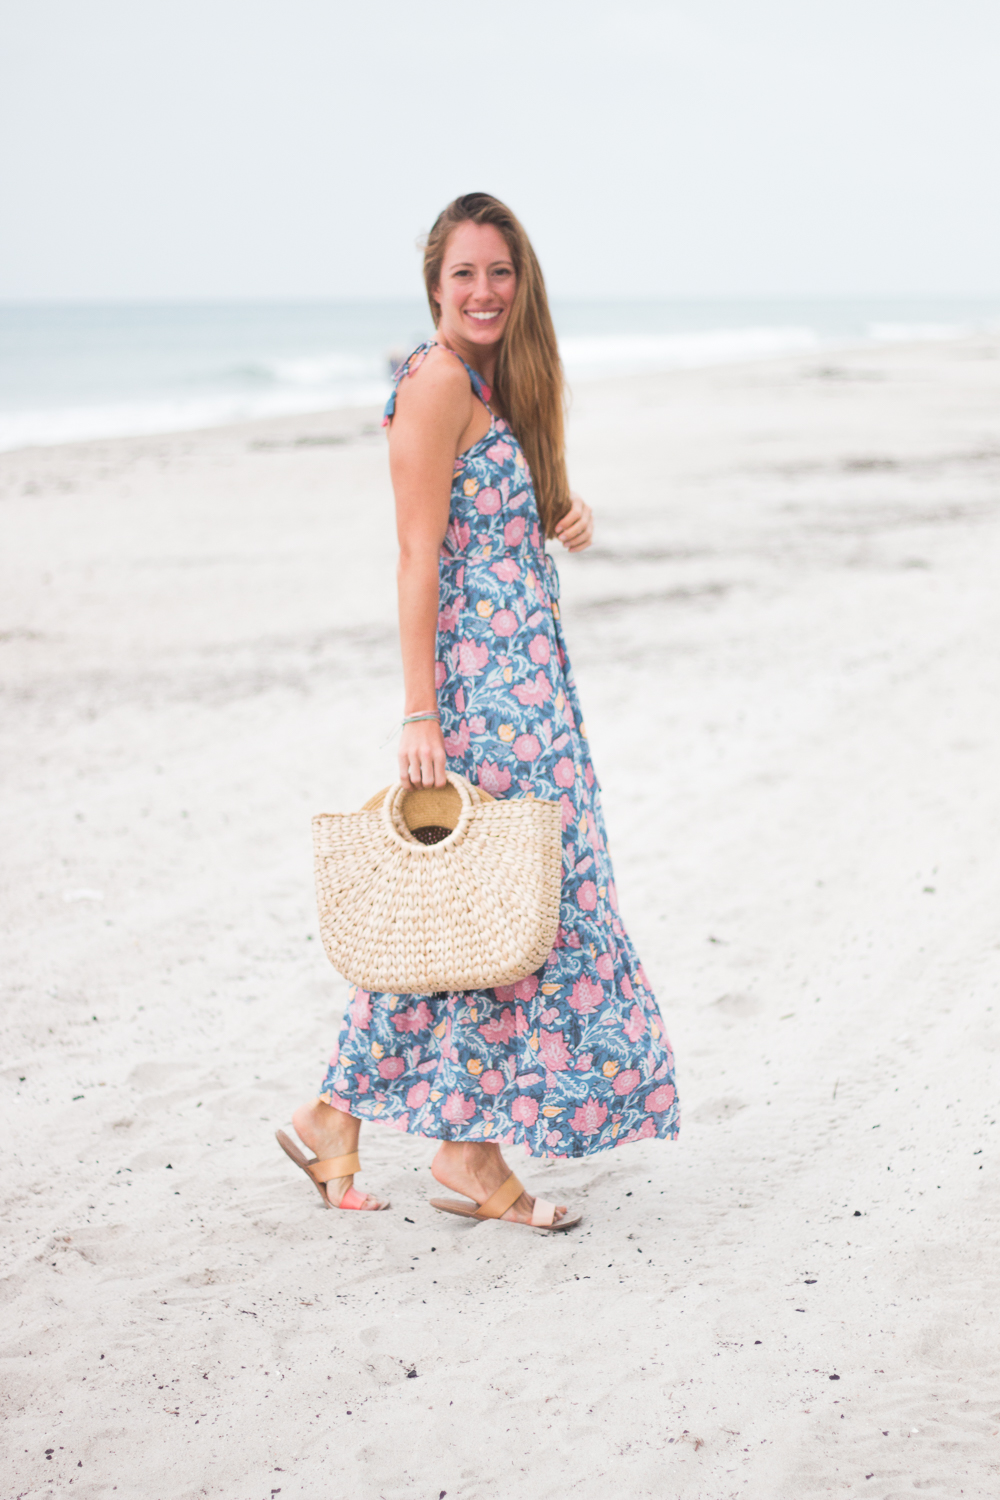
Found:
<box><xmin>433</xmin><ymin>222</ymin><xmax>517</xmax><ymax>348</ymax></box>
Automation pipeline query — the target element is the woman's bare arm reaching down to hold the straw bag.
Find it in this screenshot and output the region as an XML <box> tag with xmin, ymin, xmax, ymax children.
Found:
<box><xmin>388</xmin><ymin>350</ymin><xmax>472</xmax><ymax>786</ymax></box>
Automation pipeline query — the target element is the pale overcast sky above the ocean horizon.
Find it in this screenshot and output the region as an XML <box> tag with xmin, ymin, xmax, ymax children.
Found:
<box><xmin>0</xmin><ymin>0</ymin><xmax>1000</xmax><ymax>299</ymax></box>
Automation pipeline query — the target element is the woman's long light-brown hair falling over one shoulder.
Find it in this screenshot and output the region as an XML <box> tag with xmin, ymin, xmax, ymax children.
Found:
<box><xmin>424</xmin><ymin>192</ymin><xmax>570</xmax><ymax>537</ymax></box>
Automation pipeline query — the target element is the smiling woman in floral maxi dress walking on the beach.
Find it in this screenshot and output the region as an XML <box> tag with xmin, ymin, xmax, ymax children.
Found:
<box><xmin>282</xmin><ymin>194</ymin><xmax>678</xmax><ymax>1229</ymax></box>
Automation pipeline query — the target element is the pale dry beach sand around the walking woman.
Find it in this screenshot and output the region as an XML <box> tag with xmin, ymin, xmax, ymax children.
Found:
<box><xmin>0</xmin><ymin>339</ymin><xmax>1000</xmax><ymax>1500</ymax></box>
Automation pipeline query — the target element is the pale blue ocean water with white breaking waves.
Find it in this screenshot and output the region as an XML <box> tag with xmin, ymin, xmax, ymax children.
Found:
<box><xmin>0</xmin><ymin>296</ymin><xmax>1000</xmax><ymax>449</ymax></box>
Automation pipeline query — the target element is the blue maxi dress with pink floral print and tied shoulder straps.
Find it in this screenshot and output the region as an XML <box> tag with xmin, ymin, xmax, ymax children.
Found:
<box><xmin>321</xmin><ymin>344</ymin><xmax>678</xmax><ymax>1157</ymax></box>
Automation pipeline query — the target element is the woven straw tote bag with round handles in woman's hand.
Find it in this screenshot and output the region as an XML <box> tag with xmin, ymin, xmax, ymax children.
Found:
<box><xmin>312</xmin><ymin>771</ymin><xmax>562</xmax><ymax>995</ymax></box>
